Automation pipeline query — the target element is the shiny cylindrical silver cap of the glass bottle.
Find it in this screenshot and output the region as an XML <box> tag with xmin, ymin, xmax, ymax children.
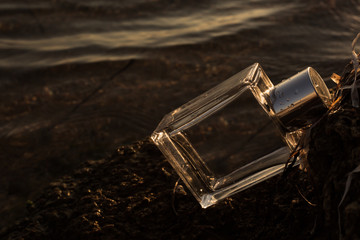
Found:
<box><xmin>267</xmin><ymin>67</ymin><xmax>331</xmax><ymax>130</ymax></box>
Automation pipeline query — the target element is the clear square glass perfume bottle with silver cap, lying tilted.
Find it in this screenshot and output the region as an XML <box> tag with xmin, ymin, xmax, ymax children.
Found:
<box><xmin>151</xmin><ymin>63</ymin><xmax>331</xmax><ymax>208</ymax></box>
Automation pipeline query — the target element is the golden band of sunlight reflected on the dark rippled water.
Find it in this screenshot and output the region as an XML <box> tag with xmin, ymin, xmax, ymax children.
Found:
<box><xmin>0</xmin><ymin>2</ymin><xmax>296</xmax><ymax>68</ymax></box>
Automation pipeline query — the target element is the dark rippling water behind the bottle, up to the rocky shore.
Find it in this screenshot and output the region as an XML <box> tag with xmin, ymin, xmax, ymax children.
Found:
<box><xmin>0</xmin><ymin>0</ymin><xmax>360</xmax><ymax>227</ymax></box>
